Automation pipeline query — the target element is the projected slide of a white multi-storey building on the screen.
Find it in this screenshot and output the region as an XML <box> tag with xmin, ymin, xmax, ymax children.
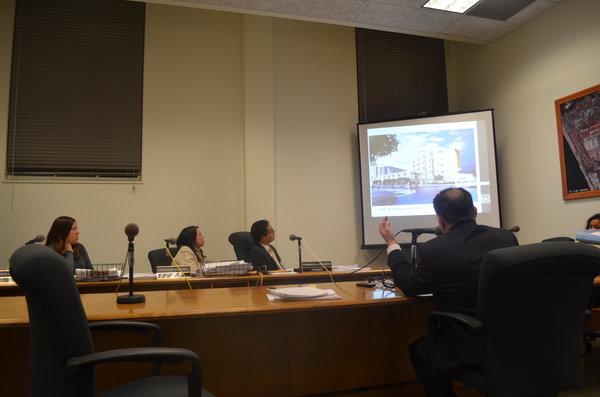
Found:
<box><xmin>368</xmin><ymin>122</ymin><xmax>480</xmax><ymax>216</ymax></box>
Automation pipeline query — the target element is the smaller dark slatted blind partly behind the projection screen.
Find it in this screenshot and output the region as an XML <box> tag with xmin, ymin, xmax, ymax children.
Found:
<box><xmin>356</xmin><ymin>28</ymin><xmax>448</xmax><ymax>123</ymax></box>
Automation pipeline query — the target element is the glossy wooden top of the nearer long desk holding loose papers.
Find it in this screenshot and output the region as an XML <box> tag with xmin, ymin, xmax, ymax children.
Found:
<box><xmin>0</xmin><ymin>282</ymin><xmax>415</xmax><ymax>326</ymax></box>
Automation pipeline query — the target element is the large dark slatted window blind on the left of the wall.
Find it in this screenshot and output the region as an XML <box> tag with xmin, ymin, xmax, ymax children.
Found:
<box><xmin>6</xmin><ymin>0</ymin><xmax>145</xmax><ymax>178</ymax></box>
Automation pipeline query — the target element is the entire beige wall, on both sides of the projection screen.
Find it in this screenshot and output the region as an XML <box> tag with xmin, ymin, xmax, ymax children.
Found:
<box><xmin>0</xmin><ymin>0</ymin><xmax>600</xmax><ymax>271</ymax></box>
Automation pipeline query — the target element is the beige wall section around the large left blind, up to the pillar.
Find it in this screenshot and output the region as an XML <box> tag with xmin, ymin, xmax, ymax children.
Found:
<box><xmin>0</xmin><ymin>2</ymin><xmax>244</xmax><ymax>271</ymax></box>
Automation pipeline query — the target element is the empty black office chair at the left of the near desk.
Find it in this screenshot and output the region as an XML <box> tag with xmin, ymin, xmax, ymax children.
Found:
<box><xmin>7</xmin><ymin>244</ymin><xmax>212</xmax><ymax>397</ymax></box>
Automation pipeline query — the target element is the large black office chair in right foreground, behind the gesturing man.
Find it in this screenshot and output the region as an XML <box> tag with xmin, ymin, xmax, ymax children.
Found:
<box><xmin>428</xmin><ymin>242</ymin><xmax>600</xmax><ymax>396</ymax></box>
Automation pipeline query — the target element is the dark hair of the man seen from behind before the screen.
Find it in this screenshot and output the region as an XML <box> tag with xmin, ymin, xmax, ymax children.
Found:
<box><xmin>433</xmin><ymin>187</ymin><xmax>474</xmax><ymax>225</ymax></box>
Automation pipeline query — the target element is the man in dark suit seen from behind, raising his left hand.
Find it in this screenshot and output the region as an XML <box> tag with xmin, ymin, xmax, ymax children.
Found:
<box><xmin>379</xmin><ymin>188</ymin><xmax>518</xmax><ymax>396</ymax></box>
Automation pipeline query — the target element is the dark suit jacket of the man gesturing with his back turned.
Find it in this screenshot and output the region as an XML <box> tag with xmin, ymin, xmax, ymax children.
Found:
<box><xmin>388</xmin><ymin>222</ymin><xmax>518</xmax><ymax>371</ymax></box>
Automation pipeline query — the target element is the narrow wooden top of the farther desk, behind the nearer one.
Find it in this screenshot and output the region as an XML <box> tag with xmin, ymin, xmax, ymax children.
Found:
<box><xmin>0</xmin><ymin>269</ymin><xmax>390</xmax><ymax>296</ymax></box>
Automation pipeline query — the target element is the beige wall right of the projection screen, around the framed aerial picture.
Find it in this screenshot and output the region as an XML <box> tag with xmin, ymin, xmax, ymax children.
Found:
<box><xmin>447</xmin><ymin>0</ymin><xmax>600</xmax><ymax>243</ymax></box>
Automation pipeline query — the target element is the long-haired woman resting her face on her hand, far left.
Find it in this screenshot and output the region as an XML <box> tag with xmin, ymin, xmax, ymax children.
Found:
<box><xmin>46</xmin><ymin>216</ymin><xmax>92</xmax><ymax>271</ymax></box>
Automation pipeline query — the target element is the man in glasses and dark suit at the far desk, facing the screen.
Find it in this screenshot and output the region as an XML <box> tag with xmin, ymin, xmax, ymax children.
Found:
<box><xmin>245</xmin><ymin>219</ymin><xmax>283</xmax><ymax>271</ymax></box>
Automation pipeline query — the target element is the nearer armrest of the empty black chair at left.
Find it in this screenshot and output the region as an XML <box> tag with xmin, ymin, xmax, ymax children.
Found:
<box><xmin>67</xmin><ymin>347</ymin><xmax>202</xmax><ymax>396</ymax></box>
